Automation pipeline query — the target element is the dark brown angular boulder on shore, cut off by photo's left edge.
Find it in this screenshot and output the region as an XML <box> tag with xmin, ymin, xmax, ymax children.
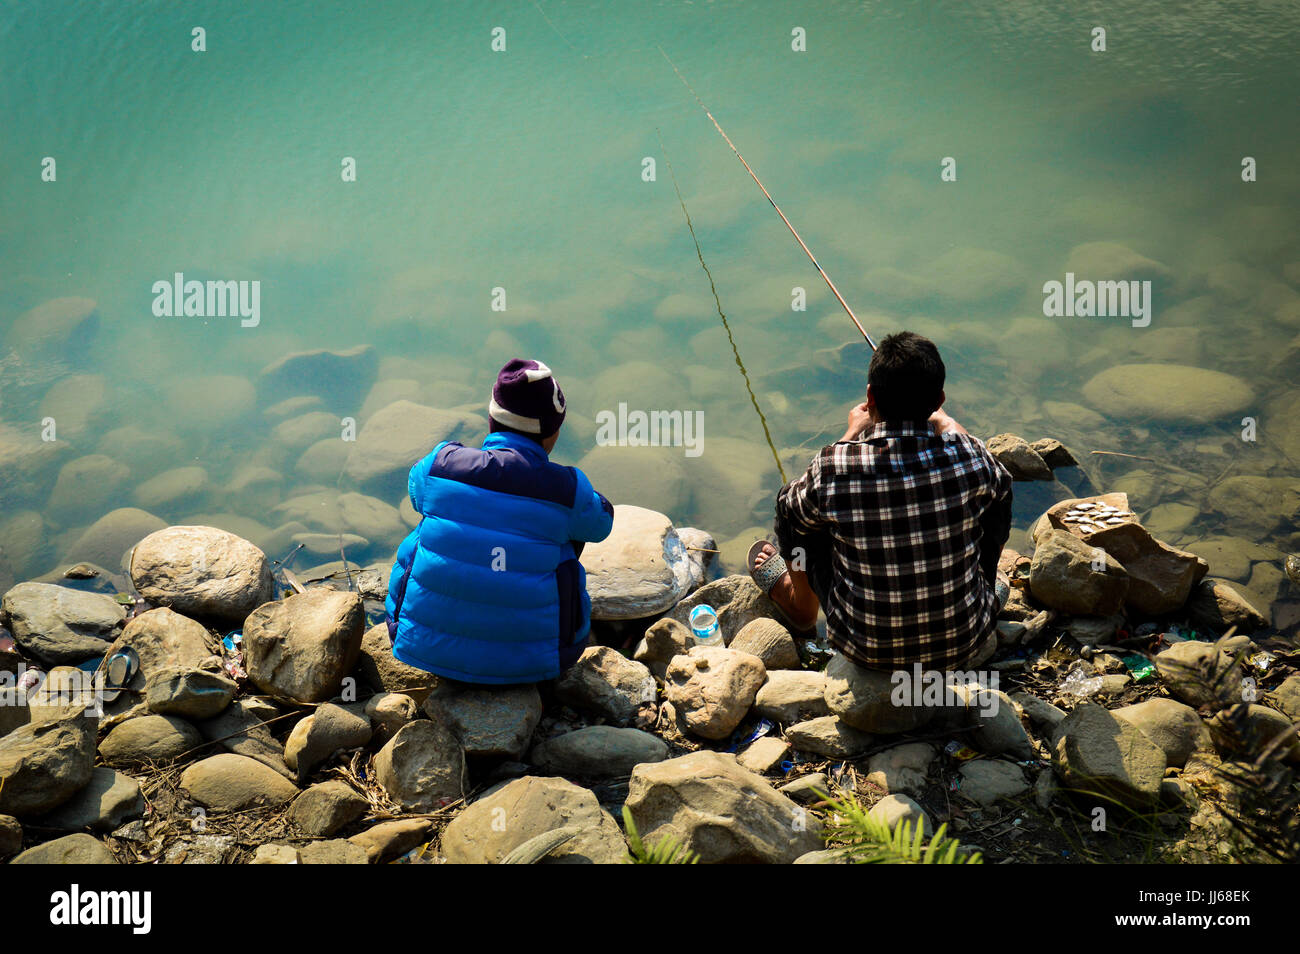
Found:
<box><xmin>0</xmin><ymin>706</ymin><xmax>98</xmax><ymax>818</ymax></box>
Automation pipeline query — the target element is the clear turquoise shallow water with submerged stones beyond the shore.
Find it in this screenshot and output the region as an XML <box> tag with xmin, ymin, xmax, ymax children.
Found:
<box><xmin>0</xmin><ymin>0</ymin><xmax>1300</xmax><ymax>629</ymax></box>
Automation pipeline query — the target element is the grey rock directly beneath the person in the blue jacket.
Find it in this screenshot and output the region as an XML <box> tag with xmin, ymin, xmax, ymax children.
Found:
<box><xmin>424</xmin><ymin>684</ymin><xmax>542</xmax><ymax>759</ymax></box>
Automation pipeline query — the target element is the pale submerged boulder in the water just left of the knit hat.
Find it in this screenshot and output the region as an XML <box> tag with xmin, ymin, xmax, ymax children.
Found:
<box><xmin>343</xmin><ymin>400</ymin><xmax>488</xmax><ymax>498</ymax></box>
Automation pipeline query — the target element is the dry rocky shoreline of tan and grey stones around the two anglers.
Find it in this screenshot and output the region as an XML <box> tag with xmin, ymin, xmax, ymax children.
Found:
<box><xmin>0</xmin><ymin>467</ymin><xmax>1300</xmax><ymax>863</ymax></box>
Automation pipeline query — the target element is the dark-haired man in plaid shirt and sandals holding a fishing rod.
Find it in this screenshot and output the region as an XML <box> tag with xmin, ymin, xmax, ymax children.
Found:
<box><xmin>751</xmin><ymin>331</ymin><xmax>1011</xmax><ymax>669</ymax></box>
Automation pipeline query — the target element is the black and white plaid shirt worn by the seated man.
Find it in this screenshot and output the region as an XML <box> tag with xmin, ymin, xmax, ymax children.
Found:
<box><xmin>776</xmin><ymin>424</ymin><xmax>1011</xmax><ymax>669</ymax></box>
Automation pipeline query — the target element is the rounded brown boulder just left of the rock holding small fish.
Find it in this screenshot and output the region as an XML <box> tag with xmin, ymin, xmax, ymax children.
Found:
<box><xmin>1030</xmin><ymin>530</ymin><xmax>1128</xmax><ymax>615</ymax></box>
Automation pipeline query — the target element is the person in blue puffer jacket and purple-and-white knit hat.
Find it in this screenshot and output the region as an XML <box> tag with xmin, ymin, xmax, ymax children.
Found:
<box><xmin>387</xmin><ymin>357</ymin><xmax>614</xmax><ymax>685</ymax></box>
